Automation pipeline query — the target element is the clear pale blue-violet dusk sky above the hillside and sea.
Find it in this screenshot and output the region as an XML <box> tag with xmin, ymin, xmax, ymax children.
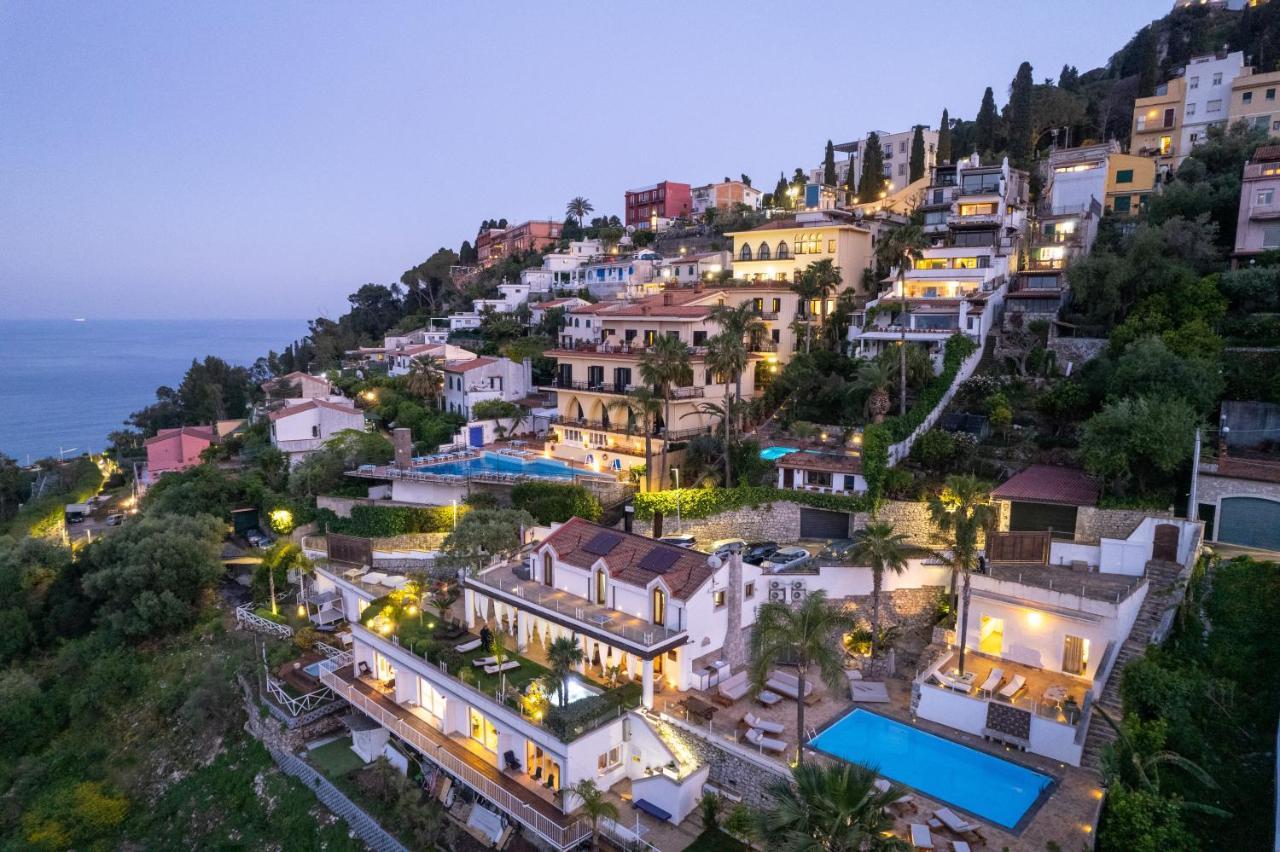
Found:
<box><xmin>0</xmin><ymin>0</ymin><xmax>1171</xmax><ymax>319</ymax></box>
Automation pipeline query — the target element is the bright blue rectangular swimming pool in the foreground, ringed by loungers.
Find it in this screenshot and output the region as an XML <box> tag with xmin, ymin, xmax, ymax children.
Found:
<box><xmin>809</xmin><ymin>709</ymin><xmax>1053</xmax><ymax>828</ymax></box>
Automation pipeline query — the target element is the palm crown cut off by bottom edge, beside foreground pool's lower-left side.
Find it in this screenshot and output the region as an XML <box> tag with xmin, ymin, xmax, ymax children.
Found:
<box><xmin>756</xmin><ymin>764</ymin><xmax>911</xmax><ymax>852</ymax></box>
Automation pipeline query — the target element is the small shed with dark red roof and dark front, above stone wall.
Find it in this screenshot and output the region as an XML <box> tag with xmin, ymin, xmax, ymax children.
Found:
<box><xmin>991</xmin><ymin>464</ymin><xmax>1102</xmax><ymax>539</ymax></box>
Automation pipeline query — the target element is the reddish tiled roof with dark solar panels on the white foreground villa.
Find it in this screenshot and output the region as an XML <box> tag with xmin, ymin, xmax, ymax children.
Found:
<box><xmin>543</xmin><ymin>518</ymin><xmax>712</xmax><ymax>600</ymax></box>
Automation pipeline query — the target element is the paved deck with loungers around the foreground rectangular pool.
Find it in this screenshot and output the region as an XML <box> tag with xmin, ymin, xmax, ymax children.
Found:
<box><xmin>658</xmin><ymin>647</ymin><xmax>1102</xmax><ymax>852</ymax></box>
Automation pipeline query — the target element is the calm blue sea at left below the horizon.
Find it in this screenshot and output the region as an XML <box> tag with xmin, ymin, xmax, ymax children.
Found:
<box><xmin>0</xmin><ymin>319</ymin><xmax>307</xmax><ymax>464</ymax></box>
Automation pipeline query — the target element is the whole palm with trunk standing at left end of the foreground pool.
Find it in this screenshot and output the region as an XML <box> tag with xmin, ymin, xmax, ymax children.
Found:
<box><xmin>749</xmin><ymin>591</ymin><xmax>854</xmax><ymax>762</ymax></box>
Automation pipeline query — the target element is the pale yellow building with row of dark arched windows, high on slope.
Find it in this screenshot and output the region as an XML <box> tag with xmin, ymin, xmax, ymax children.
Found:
<box><xmin>730</xmin><ymin>210</ymin><xmax>873</xmax><ymax>294</ymax></box>
